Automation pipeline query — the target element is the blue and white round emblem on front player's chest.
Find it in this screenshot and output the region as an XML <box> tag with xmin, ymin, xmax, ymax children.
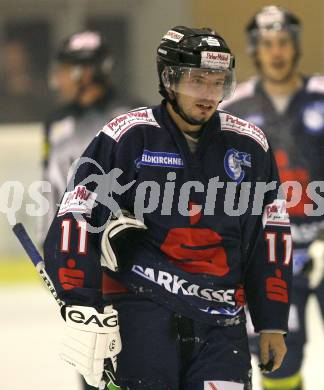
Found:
<box><xmin>224</xmin><ymin>149</ymin><xmax>251</xmax><ymax>184</ymax></box>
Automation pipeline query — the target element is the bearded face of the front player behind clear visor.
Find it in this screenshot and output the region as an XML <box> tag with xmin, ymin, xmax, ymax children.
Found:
<box><xmin>175</xmin><ymin>69</ymin><xmax>225</xmax><ymax>124</ymax></box>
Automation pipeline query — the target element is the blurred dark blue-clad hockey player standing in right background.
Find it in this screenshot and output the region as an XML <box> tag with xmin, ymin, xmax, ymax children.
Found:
<box><xmin>222</xmin><ymin>6</ymin><xmax>324</xmax><ymax>390</ymax></box>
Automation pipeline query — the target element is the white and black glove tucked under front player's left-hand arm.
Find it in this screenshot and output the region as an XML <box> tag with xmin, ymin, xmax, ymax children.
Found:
<box><xmin>101</xmin><ymin>210</ymin><xmax>147</xmax><ymax>272</ymax></box>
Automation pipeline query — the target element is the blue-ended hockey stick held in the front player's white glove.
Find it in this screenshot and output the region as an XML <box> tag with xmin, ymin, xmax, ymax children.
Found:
<box><xmin>12</xmin><ymin>223</ymin><xmax>122</xmax><ymax>390</ymax></box>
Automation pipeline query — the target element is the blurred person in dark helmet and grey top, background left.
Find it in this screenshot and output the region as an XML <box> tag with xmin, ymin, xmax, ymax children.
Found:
<box><xmin>40</xmin><ymin>30</ymin><xmax>138</xmax><ymax>242</ymax></box>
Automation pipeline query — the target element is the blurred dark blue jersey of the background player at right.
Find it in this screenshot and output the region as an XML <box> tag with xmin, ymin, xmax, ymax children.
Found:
<box><xmin>222</xmin><ymin>75</ymin><xmax>324</xmax><ymax>275</ymax></box>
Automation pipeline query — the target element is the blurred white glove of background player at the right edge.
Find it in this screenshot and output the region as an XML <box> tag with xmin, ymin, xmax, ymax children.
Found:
<box><xmin>308</xmin><ymin>238</ymin><xmax>324</xmax><ymax>289</ymax></box>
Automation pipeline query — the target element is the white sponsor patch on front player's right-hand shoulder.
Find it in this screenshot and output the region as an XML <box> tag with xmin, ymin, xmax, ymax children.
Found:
<box><xmin>219</xmin><ymin>112</ymin><xmax>269</xmax><ymax>151</ymax></box>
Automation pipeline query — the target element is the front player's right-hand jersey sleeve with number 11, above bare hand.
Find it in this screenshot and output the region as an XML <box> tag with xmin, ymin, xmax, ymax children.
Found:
<box><xmin>244</xmin><ymin>149</ymin><xmax>292</xmax><ymax>332</ymax></box>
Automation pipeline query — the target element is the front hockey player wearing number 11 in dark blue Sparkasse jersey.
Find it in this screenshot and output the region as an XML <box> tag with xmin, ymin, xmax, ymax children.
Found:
<box><xmin>45</xmin><ymin>26</ymin><xmax>292</xmax><ymax>390</ymax></box>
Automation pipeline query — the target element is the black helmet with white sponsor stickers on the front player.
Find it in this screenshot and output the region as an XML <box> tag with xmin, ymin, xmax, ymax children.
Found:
<box><xmin>157</xmin><ymin>26</ymin><xmax>235</xmax><ymax>106</ymax></box>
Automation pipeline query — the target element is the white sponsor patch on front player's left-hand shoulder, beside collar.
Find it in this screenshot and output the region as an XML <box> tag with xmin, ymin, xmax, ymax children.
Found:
<box><xmin>102</xmin><ymin>109</ymin><xmax>161</xmax><ymax>142</ymax></box>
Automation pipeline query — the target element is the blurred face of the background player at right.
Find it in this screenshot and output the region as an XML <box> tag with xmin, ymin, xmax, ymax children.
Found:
<box><xmin>256</xmin><ymin>31</ymin><xmax>296</xmax><ymax>83</ymax></box>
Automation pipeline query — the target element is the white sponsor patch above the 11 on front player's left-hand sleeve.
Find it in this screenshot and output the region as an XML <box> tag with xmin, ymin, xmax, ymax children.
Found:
<box><xmin>57</xmin><ymin>186</ymin><xmax>97</xmax><ymax>217</ymax></box>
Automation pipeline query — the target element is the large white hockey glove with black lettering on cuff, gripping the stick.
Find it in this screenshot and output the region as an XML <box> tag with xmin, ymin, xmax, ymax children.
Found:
<box><xmin>60</xmin><ymin>306</ymin><xmax>121</xmax><ymax>388</ymax></box>
